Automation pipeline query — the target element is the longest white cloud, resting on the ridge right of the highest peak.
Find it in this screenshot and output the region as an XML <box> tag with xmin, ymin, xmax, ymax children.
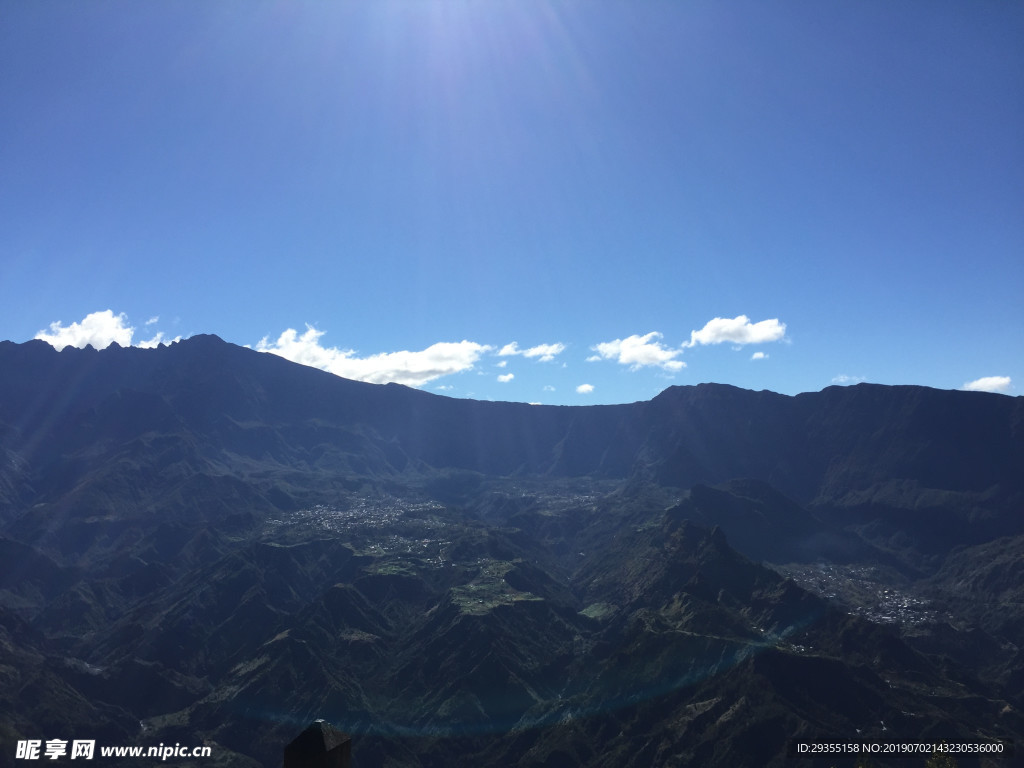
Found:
<box><xmin>256</xmin><ymin>326</ymin><xmax>492</xmax><ymax>387</ymax></box>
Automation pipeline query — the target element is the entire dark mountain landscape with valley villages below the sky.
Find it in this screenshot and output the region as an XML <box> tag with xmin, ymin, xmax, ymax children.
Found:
<box><xmin>0</xmin><ymin>336</ymin><xmax>1024</xmax><ymax>767</ymax></box>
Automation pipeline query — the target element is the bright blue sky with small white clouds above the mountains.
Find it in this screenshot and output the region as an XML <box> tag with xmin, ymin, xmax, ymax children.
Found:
<box><xmin>0</xmin><ymin>0</ymin><xmax>1024</xmax><ymax>404</ymax></box>
